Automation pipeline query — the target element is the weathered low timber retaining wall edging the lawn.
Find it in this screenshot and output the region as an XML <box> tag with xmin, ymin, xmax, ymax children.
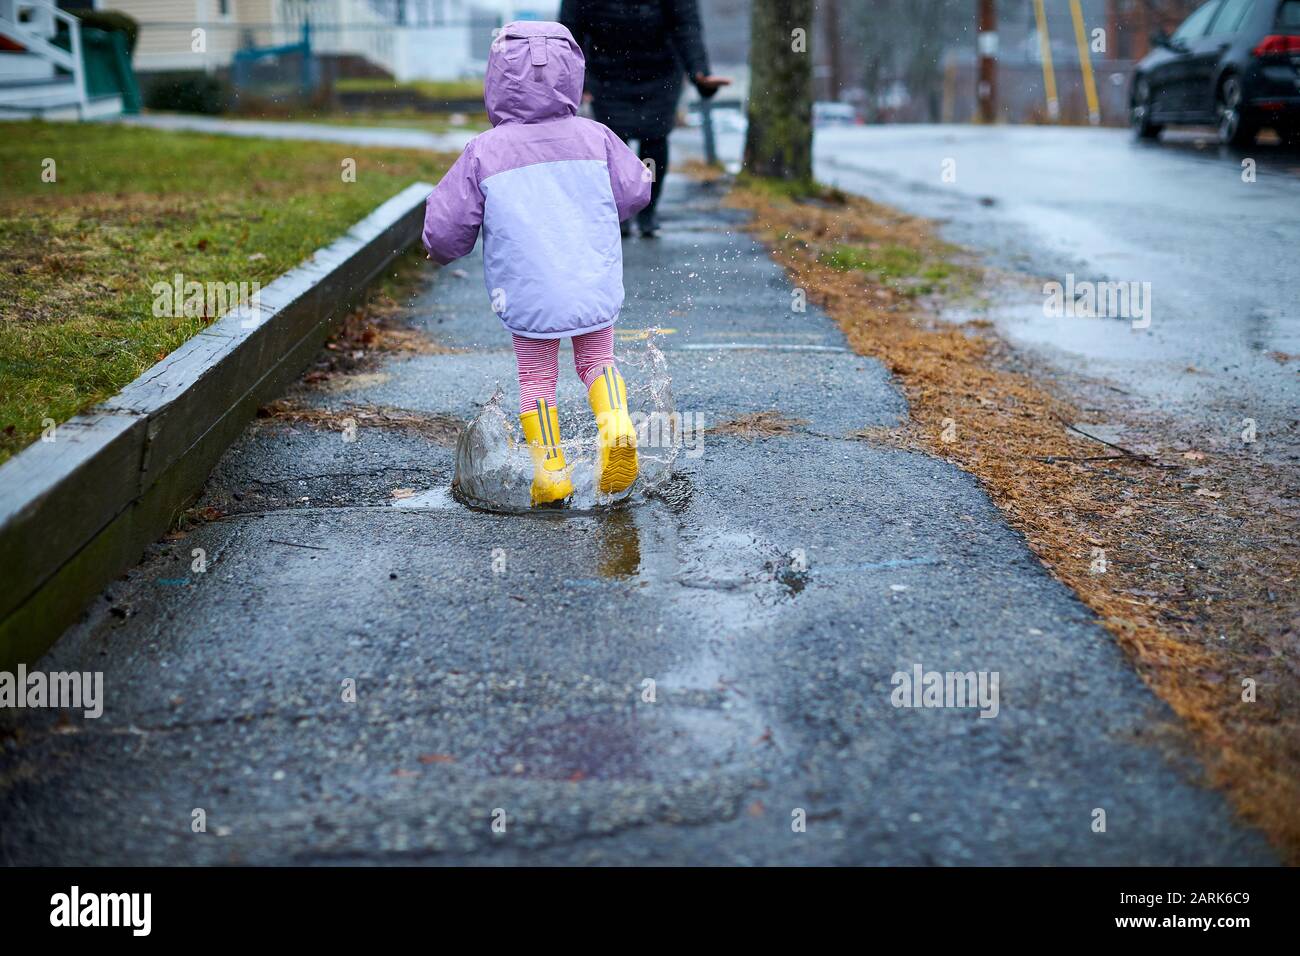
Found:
<box><xmin>0</xmin><ymin>182</ymin><xmax>433</xmax><ymax>670</ymax></box>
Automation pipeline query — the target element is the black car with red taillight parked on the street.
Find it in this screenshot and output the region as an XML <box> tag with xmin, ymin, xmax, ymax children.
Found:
<box><xmin>1130</xmin><ymin>0</ymin><xmax>1300</xmax><ymax>146</ymax></box>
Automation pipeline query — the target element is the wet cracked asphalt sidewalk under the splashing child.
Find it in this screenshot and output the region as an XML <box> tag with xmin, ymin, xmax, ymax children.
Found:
<box><xmin>0</xmin><ymin>177</ymin><xmax>1273</xmax><ymax>864</ymax></box>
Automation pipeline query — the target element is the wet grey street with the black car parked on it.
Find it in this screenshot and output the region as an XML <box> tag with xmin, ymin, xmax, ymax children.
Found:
<box><xmin>681</xmin><ymin>126</ymin><xmax>1300</xmax><ymax>458</ymax></box>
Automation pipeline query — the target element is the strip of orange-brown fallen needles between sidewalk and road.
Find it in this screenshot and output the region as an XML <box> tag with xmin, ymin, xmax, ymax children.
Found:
<box><xmin>722</xmin><ymin>170</ymin><xmax>1300</xmax><ymax>862</ymax></box>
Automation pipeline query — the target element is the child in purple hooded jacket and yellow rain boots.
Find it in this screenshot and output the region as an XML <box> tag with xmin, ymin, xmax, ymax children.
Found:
<box><xmin>424</xmin><ymin>21</ymin><xmax>651</xmax><ymax>507</ymax></box>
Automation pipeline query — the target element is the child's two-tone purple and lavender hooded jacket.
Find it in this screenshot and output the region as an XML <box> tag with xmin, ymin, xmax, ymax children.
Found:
<box><xmin>424</xmin><ymin>21</ymin><xmax>650</xmax><ymax>338</ymax></box>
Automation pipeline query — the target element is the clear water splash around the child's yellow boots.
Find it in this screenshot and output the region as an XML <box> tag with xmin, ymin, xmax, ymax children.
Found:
<box><xmin>451</xmin><ymin>330</ymin><xmax>683</xmax><ymax>514</ymax></box>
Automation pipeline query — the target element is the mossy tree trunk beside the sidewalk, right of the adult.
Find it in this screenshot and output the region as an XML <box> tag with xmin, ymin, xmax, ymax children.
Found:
<box><xmin>745</xmin><ymin>0</ymin><xmax>813</xmax><ymax>182</ymax></box>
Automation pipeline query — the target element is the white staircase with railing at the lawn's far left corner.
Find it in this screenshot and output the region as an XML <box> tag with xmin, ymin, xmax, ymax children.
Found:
<box><xmin>0</xmin><ymin>0</ymin><xmax>122</xmax><ymax>120</ymax></box>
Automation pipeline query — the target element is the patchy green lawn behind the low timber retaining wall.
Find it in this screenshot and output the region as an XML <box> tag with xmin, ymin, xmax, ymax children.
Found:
<box><xmin>0</xmin><ymin>122</ymin><xmax>454</xmax><ymax>462</ymax></box>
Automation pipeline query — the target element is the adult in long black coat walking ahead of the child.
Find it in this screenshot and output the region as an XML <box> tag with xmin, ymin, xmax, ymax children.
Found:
<box><xmin>560</xmin><ymin>0</ymin><xmax>731</xmax><ymax>237</ymax></box>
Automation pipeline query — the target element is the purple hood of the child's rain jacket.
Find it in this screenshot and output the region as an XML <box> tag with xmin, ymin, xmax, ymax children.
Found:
<box><xmin>484</xmin><ymin>21</ymin><xmax>586</xmax><ymax>126</ymax></box>
